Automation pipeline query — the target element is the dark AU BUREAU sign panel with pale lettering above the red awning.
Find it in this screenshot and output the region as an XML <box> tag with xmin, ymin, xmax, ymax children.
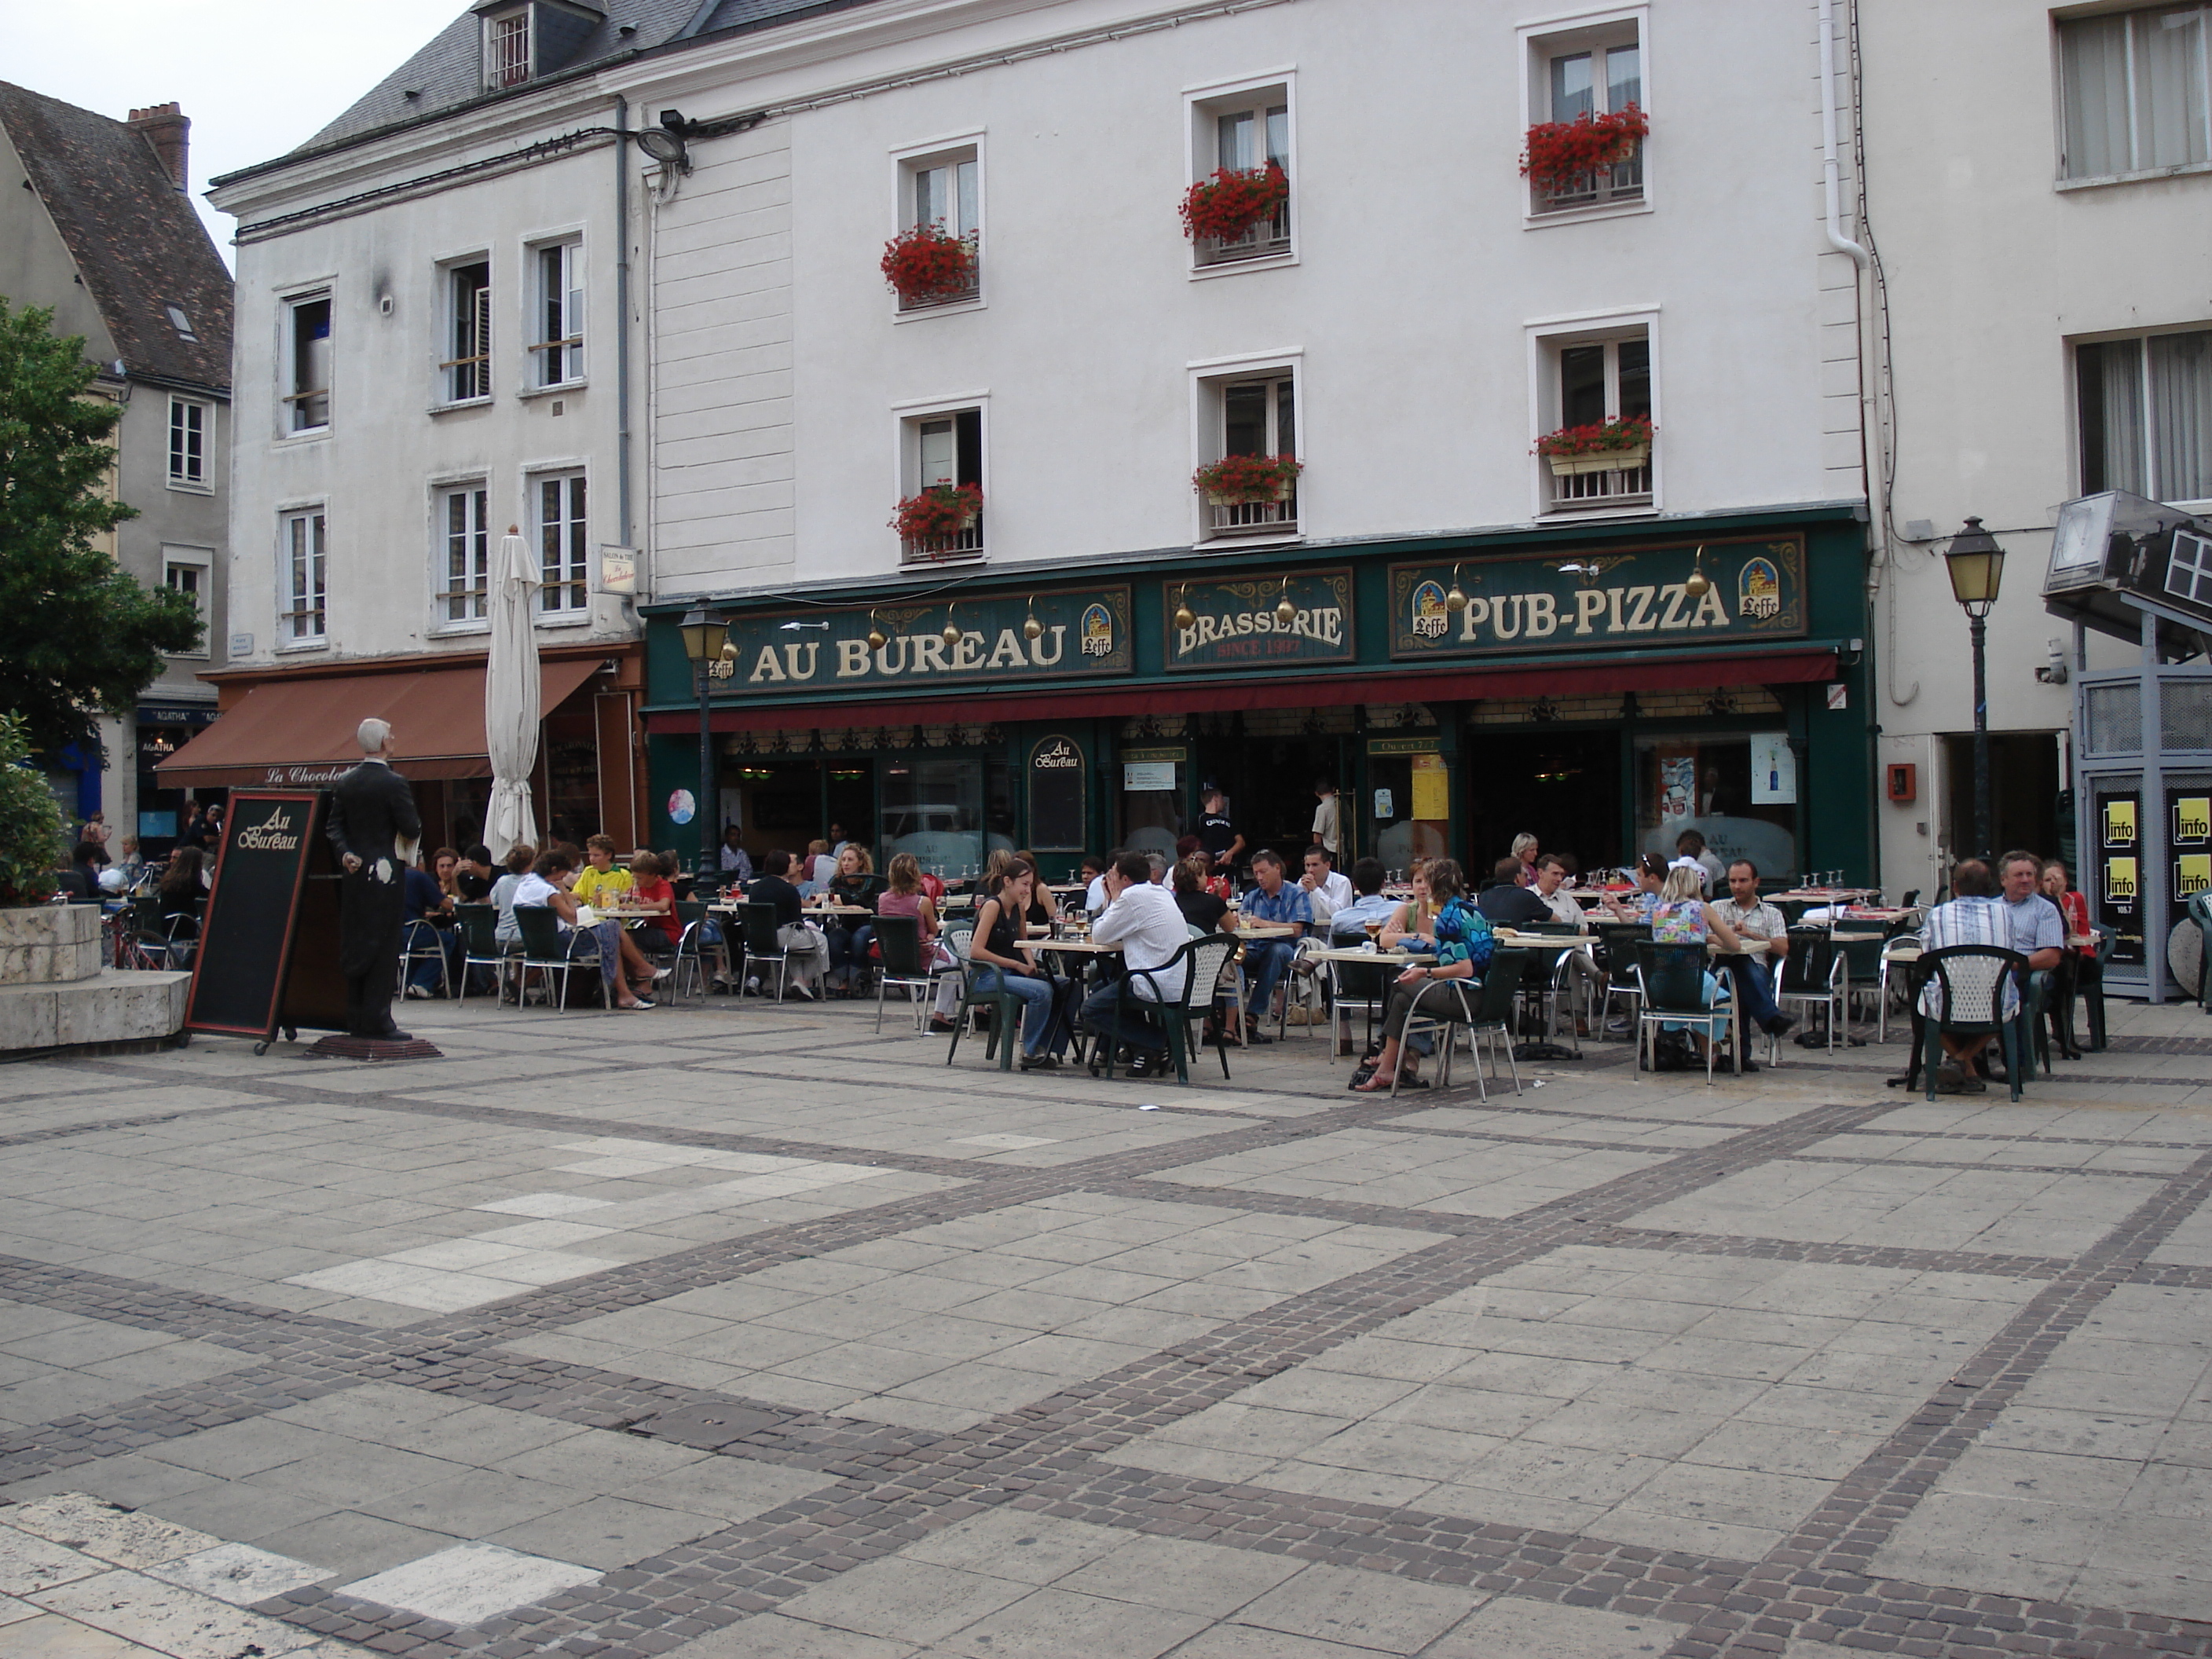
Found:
<box><xmin>710</xmin><ymin>588</ymin><xmax>1133</xmax><ymax>692</ymax></box>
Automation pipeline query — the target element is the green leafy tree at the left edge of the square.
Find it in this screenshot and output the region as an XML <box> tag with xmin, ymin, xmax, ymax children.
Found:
<box><xmin>0</xmin><ymin>298</ymin><xmax>201</xmax><ymax>754</ymax></box>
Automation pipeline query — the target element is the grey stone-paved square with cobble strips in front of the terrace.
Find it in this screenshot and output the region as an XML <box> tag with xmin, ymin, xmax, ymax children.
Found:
<box><xmin>0</xmin><ymin>1000</ymin><xmax>2212</xmax><ymax>1659</ymax></box>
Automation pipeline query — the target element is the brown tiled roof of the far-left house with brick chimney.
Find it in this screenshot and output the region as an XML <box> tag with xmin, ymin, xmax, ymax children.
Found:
<box><xmin>0</xmin><ymin>82</ymin><xmax>230</xmax><ymax>391</ymax></box>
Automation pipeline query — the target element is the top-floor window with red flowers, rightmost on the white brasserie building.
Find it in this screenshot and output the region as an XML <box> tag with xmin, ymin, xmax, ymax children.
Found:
<box><xmin>1522</xmin><ymin>16</ymin><xmax>1646</xmax><ymax>214</ymax></box>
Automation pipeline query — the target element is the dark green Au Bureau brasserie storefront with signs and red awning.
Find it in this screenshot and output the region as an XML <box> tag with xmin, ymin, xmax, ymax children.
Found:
<box><xmin>646</xmin><ymin>507</ymin><xmax>1876</xmax><ymax>898</ymax></box>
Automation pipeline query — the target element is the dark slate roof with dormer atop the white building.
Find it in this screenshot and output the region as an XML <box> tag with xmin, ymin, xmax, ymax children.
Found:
<box><xmin>287</xmin><ymin>0</ymin><xmax>865</xmax><ymax>166</ymax></box>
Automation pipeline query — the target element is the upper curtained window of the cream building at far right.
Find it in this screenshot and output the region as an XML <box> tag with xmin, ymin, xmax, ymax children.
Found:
<box><xmin>2060</xmin><ymin>5</ymin><xmax>2212</xmax><ymax>179</ymax></box>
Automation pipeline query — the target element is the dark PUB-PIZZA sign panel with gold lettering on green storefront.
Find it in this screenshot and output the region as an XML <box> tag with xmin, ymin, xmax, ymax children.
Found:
<box><xmin>1389</xmin><ymin>537</ymin><xmax>1807</xmax><ymax>657</ymax></box>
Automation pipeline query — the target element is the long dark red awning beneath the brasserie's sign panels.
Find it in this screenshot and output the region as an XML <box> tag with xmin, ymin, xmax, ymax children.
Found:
<box><xmin>646</xmin><ymin>648</ymin><xmax>1836</xmax><ymax>734</ymax></box>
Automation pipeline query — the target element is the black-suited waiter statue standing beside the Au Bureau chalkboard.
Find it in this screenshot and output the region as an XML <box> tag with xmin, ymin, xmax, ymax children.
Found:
<box><xmin>325</xmin><ymin>719</ymin><xmax>423</xmax><ymax>1042</ymax></box>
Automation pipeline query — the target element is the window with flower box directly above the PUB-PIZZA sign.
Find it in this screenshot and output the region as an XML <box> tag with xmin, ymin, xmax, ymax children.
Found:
<box><xmin>1537</xmin><ymin>323</ymin><xmax>1653</xmax><ymax>513</ymax></box>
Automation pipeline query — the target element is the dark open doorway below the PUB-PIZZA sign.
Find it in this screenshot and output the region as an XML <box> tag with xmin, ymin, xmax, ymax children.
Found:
<box><xmin>1460</xmin><ymin>726</ymin><xmax>1624</xmax><ymax>883</ymax></box>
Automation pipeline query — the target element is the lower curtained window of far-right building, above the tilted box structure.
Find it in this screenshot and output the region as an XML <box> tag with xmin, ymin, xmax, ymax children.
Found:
<box><xmin>2075</xmin><ymin>330</ymin><xmax>2212</xmax><ymax>502</ymax></box>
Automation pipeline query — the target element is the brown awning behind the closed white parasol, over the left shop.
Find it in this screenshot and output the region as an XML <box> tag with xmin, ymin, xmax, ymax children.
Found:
<box><xmin>155</xmin><ymin>657</ymin><xmax>599</xmax><ymax>789</ymax></box>
